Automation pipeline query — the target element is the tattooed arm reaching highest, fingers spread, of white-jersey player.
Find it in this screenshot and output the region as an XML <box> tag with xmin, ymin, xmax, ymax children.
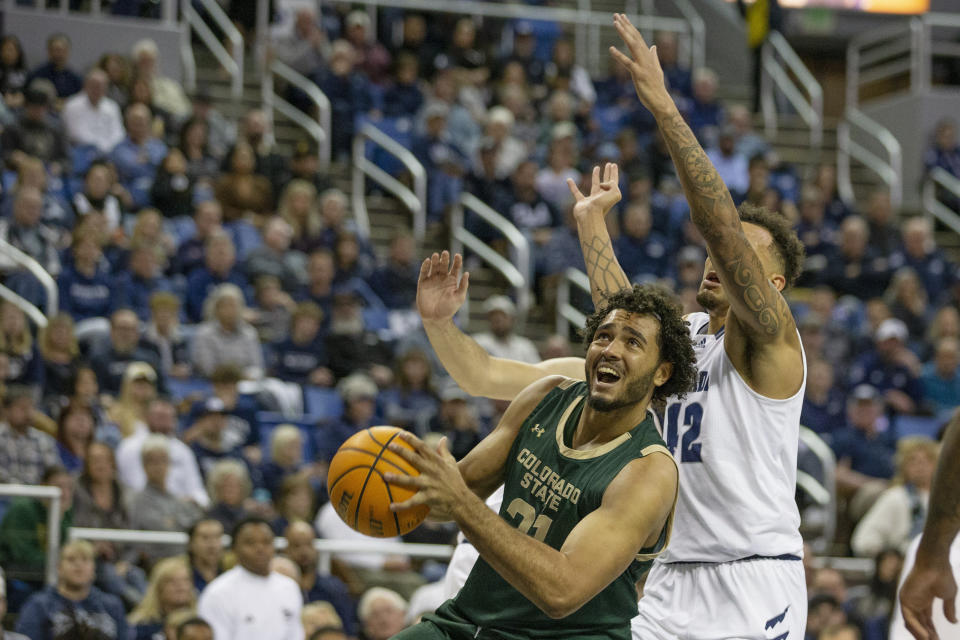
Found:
<box><xmin>610</xmin><ymin>14</ymin><xmax>795</xmax><ymax>343</ymax></box>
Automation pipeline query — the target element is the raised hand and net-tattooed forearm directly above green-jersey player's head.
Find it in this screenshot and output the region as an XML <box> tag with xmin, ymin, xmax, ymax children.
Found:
<box><xmin>567</xmin><ymin>162</ymin><xmax>630</xmax><ymax>307</ymax></box>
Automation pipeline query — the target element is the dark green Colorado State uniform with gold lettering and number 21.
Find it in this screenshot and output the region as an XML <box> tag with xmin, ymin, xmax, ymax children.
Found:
<box><xmin>440</xmin><ymin>380</ymin><xmax>673</xmax><ymax>640</ymax></box>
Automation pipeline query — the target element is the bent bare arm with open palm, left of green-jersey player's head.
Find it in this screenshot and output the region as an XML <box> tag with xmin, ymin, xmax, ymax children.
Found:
<box><xmin>417</xmin><ymin>251</ymin><xmax>585</xmax><ymax>400</ymax></box>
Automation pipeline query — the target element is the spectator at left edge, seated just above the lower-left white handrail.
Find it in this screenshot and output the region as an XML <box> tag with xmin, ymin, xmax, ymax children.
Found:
<box><xmin>0</xmin><ymin>187</ymin><xmax>60</xmax><ymax>277</ymax></box>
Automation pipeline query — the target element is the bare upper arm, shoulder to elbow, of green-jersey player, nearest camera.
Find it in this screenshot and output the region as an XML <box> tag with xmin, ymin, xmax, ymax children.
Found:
<box><xmin>554</xmin><ymin>453</ymin><xmax>678</xmax><ymax>616</ymax></box>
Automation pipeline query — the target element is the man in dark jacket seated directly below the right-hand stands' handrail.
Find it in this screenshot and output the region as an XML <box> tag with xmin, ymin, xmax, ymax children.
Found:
<box><xmin>820</xmin><ymin>216</ymin><xmax>890</xmax><ymax>298</ymax></box>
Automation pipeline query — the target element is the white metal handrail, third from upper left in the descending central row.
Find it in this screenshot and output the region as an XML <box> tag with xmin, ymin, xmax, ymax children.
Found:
<box><xmin>352</xmin><ymin>122</ymin><xmax>427</xmax><ymax>242</ymax></box>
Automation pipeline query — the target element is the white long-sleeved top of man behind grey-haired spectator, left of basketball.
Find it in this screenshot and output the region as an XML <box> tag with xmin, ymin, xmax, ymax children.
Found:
<box><xmin>117</xmin><ymin>426</ymin><xmax>210</xmax><ymax>508</ymax></box>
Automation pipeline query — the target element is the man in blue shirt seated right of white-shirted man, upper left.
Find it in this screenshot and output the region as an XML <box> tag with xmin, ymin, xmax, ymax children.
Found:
<box><xmin>110</xmin><ymin>103</ymin><xmax>167</xmax><ymax>209</ymax></box>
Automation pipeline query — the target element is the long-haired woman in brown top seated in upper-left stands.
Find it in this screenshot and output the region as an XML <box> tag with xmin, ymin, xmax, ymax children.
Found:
<box><xmin>214</xmin><ymin>142</ymin><xmax>273</xmax><ymax>226</ymax></box>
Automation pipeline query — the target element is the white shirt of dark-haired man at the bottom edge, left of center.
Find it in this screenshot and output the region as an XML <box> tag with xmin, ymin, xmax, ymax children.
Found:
<box><xmin>197</xmin><ymin>566</ymin><xmax>304</xmax><ymax>640</ymax></box>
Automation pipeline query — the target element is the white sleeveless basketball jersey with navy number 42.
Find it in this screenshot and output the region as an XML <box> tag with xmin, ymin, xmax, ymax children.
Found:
<box><xmin>658</xmin><ymin>313</ymin><xmax>807</xmax><ymax>562</ymax></box>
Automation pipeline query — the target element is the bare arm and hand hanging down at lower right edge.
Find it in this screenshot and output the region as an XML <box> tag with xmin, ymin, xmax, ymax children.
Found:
<box><xmin>900</xmin><ymin>413</ymin><xmax>960</xmax><ymax>640</ymax></box>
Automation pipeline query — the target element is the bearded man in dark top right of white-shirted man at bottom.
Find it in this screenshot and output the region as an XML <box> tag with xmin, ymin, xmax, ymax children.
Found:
<box><xmin>284</xmin><ymin>522</ymin><xmax>357</xmax><ymax>635</ymax></box>
